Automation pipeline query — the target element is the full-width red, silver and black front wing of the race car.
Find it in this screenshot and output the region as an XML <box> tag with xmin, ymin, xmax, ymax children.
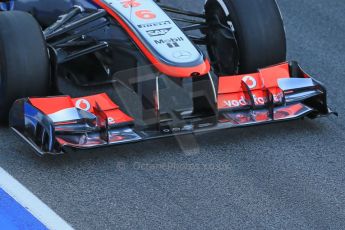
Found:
<box><xmin>10</xmin><ymin>62</ymin><xmax>333</xmax><ymax>155</ymax></box>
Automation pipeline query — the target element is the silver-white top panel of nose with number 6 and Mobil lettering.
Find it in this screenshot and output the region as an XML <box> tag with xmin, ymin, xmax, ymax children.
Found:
<box><xmin>103</xmin><ymin>0</ymin><xmax>204</xmax><ymax>67</ymax></box>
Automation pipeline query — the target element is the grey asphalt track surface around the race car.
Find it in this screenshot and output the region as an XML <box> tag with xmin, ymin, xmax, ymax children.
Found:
<box><xmin>0</xmin><ymin>0</ymin><xmax>345</xmax><ymax>229</ymax></box>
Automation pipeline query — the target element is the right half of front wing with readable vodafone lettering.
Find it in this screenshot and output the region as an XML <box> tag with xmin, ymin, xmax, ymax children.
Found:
<box><xmin>218</xmin><ymin>62</ymin><xmax>333</xmax><ymax>125</ymax></box>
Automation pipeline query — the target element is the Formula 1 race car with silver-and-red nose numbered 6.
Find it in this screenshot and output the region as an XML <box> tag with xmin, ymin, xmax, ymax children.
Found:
<box><xmin>0</xmin><ymin>0</ymin><xmax>332</xmax><ymax>155</ymax></box>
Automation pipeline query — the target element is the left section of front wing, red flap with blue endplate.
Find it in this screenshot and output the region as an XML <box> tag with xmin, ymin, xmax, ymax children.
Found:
<box><xmin>10</xmin><ymin>93</ymin><xmax>141</xmax><ymax>155</ymax></box>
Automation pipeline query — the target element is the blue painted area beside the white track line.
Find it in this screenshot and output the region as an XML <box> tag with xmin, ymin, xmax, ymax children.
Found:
<box><xmin>0</xmin><ymin>188</ymin><xmax>47</xmax><ymax>230</ymax></box>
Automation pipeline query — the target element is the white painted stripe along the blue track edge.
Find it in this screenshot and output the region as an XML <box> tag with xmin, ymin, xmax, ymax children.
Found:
<box><xmin>0</xmin><ymin>167</ymin><xmax>73</xmax><ymax>230</ymax></box>
